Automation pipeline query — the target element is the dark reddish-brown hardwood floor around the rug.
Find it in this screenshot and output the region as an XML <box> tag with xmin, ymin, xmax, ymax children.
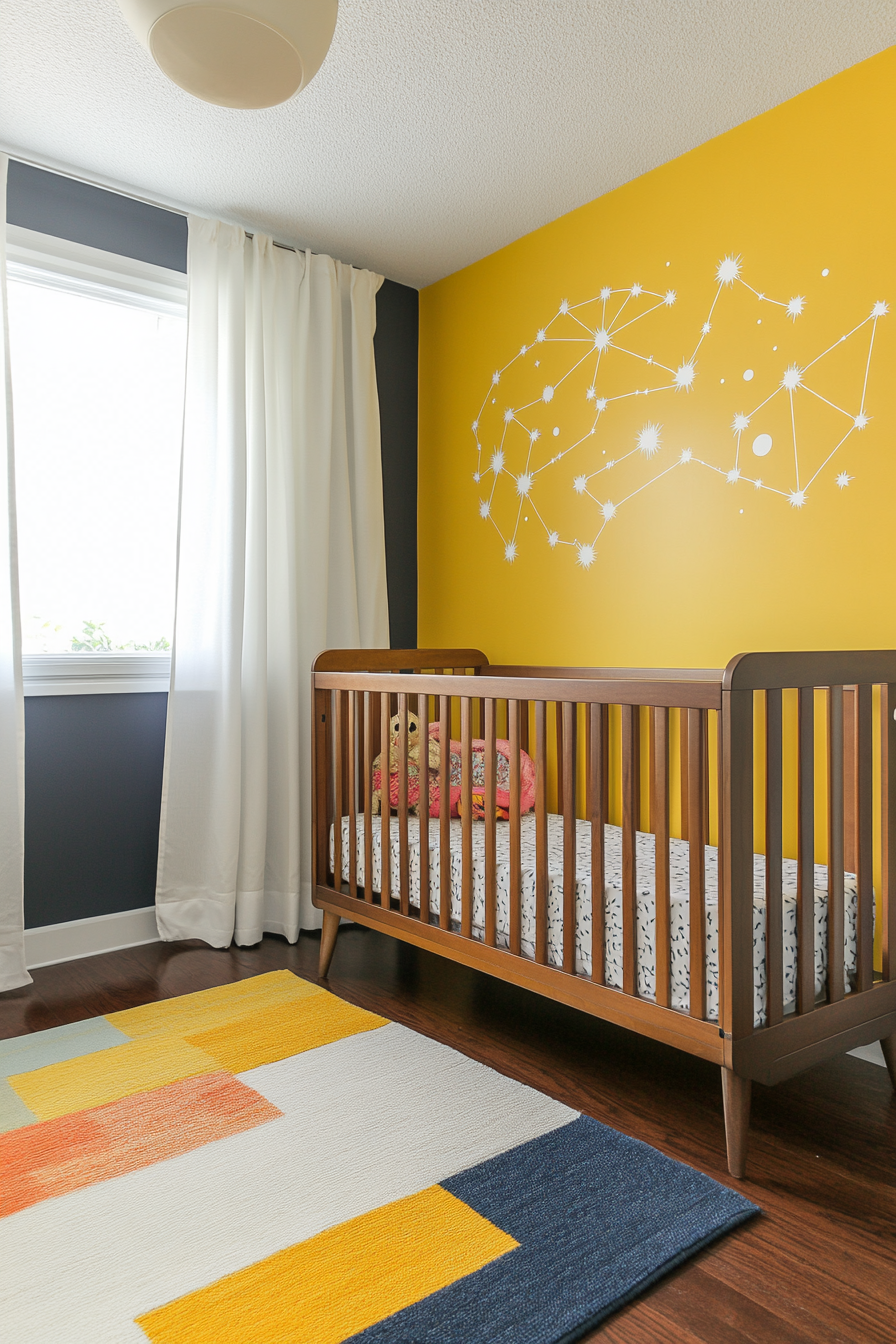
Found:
<box><xmin>0</xmin><ymin>926</ymin><xmax>896</xmax><ymax>1344</ymax></box>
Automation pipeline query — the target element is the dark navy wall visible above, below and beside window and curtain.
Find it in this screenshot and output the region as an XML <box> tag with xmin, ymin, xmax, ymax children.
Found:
<box><xmin>7</xmin><ymin>160</ymin><xmax>418</xmax><ymax>929</ymax></box>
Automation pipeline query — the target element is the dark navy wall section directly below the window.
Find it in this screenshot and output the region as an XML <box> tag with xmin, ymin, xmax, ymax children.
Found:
<box><xmin>26</xmin><ymin>692</ymin><xmax>168</xmax><ymax>929</ymax></box>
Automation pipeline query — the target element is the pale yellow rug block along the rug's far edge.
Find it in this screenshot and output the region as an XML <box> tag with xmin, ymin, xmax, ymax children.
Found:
<box><xmin>106</xmin><ymin>970</ymin><xmax>326</xmax><ymax>1038</ymax></box>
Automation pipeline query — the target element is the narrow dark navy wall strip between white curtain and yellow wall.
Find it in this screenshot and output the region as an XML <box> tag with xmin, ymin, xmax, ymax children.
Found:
<box><xmin>373</xmin><ymin>280</ymin><xmax>420</xmax><ymax>649</ymax></box>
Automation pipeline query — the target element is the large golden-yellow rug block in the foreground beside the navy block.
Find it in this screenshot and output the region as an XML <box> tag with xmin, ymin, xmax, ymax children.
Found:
<box><xmin>137</xmin><ymin>1185</ymin><xmax>519</xmax><ymax>1344</ymax></box>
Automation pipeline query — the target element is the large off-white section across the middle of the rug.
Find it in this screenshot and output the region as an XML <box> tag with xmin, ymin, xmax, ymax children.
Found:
<box><xmin>0</xmin><ymin>1024</ymin><xmax>578</xmax><ymax>1344</ymax></box>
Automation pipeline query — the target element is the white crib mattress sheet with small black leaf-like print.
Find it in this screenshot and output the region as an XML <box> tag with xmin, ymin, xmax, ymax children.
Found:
<box><xmin>330</xmin><ymin>813</ymin><xmax>857</xmax><ymax>1027</ymax></box>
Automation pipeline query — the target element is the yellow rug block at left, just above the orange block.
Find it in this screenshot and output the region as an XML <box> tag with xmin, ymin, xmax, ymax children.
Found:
<box><xmin>9</xmin><ymin>1036</ymin><xmax>220</xmax><ymax>1120</ymax></box>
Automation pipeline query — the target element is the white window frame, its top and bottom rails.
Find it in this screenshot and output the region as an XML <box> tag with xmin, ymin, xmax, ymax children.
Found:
<box><xmin>7</xmin><ymin>224</ymin><xmax>187</xmax><ymax>695</ymax></box>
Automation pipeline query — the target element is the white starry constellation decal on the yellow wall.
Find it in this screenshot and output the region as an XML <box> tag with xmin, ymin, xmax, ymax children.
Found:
<box><xmin>473</xmin><ymin>255</ymin><xmax>889</xmax><ymax>570</ymax></box>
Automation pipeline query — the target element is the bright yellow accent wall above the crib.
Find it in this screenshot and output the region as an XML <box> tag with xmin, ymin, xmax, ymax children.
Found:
<box><xmin>418</xmin><ymin>48</ymin><xmax>896</xmax><ymax>667</ymax></box>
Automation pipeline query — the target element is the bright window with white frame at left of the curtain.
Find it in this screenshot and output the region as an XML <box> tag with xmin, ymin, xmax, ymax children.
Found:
<box><xmin>8</xmin><ymin>227</ymin><xmax>187</xmax><ymax>694</ymax></box>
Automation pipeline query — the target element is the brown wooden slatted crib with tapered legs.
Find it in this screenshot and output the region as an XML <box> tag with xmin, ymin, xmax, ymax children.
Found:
<box><xmin>313</xmin><ymin>649</ymin><xmax>896</xmax><ymax>1177</ymax></box>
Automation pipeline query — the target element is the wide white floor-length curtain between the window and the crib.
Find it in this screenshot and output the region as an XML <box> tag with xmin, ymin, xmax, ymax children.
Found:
<box><xmin>156</xmin><ymin>218</ymin><xmax>388</xmax><ymax>948</ymax></box>
